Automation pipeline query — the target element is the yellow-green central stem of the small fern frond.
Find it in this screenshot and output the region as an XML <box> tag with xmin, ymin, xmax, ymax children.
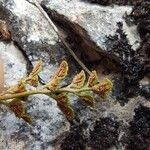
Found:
<box><xmin>0</xmin><ymin>87</ymin><xmax>91</xmax><ymax>101</ymax></box>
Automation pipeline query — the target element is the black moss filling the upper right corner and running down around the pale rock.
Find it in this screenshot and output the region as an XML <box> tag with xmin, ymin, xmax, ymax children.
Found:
<box><xmin>84</xmin><ymin>0</ymin><xmax>150</xmax><ymax>105</ymax></box>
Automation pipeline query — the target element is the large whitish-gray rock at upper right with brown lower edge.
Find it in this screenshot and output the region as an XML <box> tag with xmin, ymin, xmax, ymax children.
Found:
<box><xmin>41</xmin><ymin>0</ymin><xmax>140</xmax><ymax>61</ymax></box>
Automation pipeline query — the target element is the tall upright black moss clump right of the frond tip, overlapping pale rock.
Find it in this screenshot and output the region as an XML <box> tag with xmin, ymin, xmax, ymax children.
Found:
<box><xmin>106</xmin><ymin>23</ymin><xmax>144</xmax><ymax>105</ymax></box>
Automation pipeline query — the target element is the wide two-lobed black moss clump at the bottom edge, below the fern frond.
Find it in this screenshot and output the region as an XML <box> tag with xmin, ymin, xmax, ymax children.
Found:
<box><xmin>56</xmin><ymin>117</ymin><xmax>119</xmax><ymax>150</ymax></box>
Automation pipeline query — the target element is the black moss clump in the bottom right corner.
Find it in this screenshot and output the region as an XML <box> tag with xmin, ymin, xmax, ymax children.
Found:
<box><xmin>126</xmin><ymin>105</ymin><xmax>150</xmax><ymax>150</ymax></box>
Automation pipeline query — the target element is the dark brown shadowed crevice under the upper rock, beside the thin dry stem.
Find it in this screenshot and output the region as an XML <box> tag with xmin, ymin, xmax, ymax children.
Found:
<box><xmin>42</xmin><ymin>4</ymin><xmax>129</xmax><ymax>72</ymax></box>
